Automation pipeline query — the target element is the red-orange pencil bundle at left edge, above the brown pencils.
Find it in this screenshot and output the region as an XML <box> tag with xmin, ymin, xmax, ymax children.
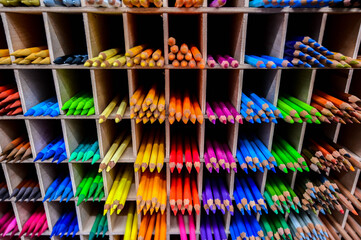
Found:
<box><xmin>0</xmin><ymin>84</ymin><xmax>23</xmax><ymax>116</ymax></box>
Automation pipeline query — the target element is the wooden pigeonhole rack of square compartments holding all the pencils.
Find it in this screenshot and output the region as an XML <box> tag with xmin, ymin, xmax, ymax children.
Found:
<box><xmin>0</xmin><ymin>0</ymin><xmax>361</xmax><ymax>240</ymax></box>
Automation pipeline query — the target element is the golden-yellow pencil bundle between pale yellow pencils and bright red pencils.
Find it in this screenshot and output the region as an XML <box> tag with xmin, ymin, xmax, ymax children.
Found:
<box><xmin>134</xmin><ymin>128</ymin><xmax>165</xmax><ymax>173</ymax></box>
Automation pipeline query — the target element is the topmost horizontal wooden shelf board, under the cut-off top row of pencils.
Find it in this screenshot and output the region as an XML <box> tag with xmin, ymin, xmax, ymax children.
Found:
<box><xmin>0</xmin><ymin>7</ymin><xmax>361</xmax><ymax>14</ymax></box>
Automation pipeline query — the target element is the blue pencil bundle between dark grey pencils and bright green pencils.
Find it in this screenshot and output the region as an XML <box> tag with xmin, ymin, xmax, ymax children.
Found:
<box><xmin>43</xmin><ymin>175</ymin><xmax>74</xmax><ymax>202</ymax></box>
